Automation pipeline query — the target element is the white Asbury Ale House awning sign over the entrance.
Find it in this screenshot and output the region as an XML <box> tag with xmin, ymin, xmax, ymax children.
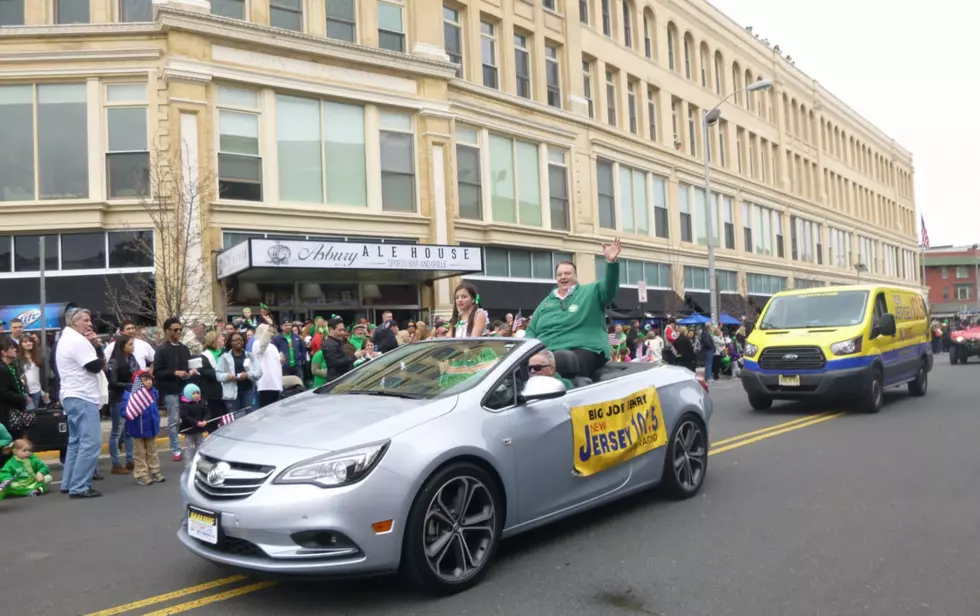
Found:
<box><xmin>216</xmin><ymin>238</ymin><xmax>483</xmax><ymax>284</ymax></box>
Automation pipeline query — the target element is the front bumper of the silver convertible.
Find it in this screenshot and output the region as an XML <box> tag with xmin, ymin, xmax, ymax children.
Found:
<box><xmin>177</xmin><ymin>454</ymin><xmax>412</xmax><ymax>577</ymax></box>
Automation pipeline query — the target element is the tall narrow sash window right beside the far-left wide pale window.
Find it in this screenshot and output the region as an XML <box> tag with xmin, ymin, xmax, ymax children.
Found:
<box><xmin>106</xmin><ymin>83</ymin><xmax>151</xmax><ymax>199</ymax></box>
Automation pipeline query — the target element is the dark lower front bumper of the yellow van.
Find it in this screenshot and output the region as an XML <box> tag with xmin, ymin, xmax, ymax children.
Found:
<box><xmin>741</xmin><ymin>366</ymin><xmax>872</xmax><ymax>400</ymax></box>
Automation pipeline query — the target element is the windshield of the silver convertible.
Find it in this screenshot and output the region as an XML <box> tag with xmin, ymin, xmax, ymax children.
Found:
<box><xmin>316</xmin><ymin>338</ymin><xmax>523</xmax><ymax>399</ymax></box>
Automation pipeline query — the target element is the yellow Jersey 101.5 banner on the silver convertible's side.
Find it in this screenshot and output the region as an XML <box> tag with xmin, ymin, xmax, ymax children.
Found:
<box><xmin>571</xmin><ymin>387</ymin><xmax>667</xmax><ymax>476</ymax></box>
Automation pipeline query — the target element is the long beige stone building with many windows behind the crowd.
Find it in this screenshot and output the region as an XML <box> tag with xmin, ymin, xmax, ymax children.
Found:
<box><xmin>0</xmin><ymin>0</ymin><xmax>919</xmax><ymax>328</ymax></box>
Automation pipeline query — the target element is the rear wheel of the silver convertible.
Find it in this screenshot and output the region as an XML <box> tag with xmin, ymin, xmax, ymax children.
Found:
<box><xmin>663</xmin><ymin>413</ymin><xmax>708</xmax><ymax>498</ymax></box>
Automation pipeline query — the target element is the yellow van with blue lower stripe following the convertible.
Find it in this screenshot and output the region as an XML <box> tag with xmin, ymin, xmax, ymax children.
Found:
<box><xmin>742</xmin><ymin>285</ymin><xmax>933</xmax><ymax>413</ymax></box>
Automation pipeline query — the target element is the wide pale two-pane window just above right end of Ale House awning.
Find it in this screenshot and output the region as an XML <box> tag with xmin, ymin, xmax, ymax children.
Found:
<box><xmin>490</xmin><ymin>135</ymin><xmax>541</xmax><ymax>227</ymax></box>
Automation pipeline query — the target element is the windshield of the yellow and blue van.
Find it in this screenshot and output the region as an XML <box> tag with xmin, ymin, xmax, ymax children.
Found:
<box><xmin>759</xmin><ymin>291</ymin><xmax>868</xmax><ymax>329</ymax></box>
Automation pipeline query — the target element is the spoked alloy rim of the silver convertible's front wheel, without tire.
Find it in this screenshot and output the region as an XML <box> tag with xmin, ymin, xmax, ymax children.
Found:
<box><xmin>422</xmin><ymin>476</ymin><xmax>497</xmax><ymax>583</ymax></box>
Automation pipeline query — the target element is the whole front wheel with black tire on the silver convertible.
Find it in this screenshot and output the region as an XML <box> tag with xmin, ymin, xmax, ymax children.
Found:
<box><xmin>401</xmin><ymin>462</ymin><xmax>504</xmax><ymax>595</ymax></box>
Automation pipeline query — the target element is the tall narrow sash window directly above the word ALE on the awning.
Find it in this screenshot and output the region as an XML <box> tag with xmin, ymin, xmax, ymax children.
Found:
<box><xmin>380</xmin><ymin>111</ymin><xmax>415</xmax><ymax>212</ymax></box>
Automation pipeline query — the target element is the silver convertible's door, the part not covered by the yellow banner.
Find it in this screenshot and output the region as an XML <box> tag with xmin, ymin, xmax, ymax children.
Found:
<box><xmin>487</xmin><ymin>362</ymin><xmax>631</xmax><ymax>524</ymax></box>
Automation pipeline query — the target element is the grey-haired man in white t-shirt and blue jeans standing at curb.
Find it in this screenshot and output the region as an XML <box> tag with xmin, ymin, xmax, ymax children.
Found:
<box><xmin>55</xmin><ymin>309</ymin><xmax>105</xmax><ymax>498</ymax></box>
